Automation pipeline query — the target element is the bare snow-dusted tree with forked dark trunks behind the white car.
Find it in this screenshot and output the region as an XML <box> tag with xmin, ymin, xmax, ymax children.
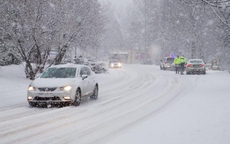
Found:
<box><xmin>0</xmin><ymin>0</ymin><xmax>104</xmax><ymax>79</ymax></box>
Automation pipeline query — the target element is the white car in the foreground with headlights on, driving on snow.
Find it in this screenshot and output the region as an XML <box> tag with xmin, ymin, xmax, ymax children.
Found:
<box><xmin>27</xmin><ymin>64</ymin><xmax>98</xmax><ymax>107</ymax></box>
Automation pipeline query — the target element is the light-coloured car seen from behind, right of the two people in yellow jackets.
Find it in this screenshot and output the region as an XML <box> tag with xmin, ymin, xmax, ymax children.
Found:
<box><xmin>186</xmin><ymin>59</ymin><xmax>206</xmax><ymax>74</ymax></box>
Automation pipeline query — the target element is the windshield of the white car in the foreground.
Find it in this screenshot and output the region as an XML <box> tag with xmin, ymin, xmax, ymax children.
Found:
<box><xmin>41</xmin><ymin>68</ymin><xmax>76</xmax><ymax>78</ymax></box>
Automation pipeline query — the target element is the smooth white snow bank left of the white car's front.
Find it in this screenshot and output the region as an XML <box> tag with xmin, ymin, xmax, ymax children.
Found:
<box><xmin>0</xmin><ymin>64</ymin><xmax>31</xmax><ymax>108</ymax></box>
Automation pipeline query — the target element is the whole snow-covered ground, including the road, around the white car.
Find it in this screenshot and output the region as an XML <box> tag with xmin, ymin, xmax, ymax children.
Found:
<box><xmin>0</xmin><ymin>65</ymin><xmax>230</xmax><ymax>144</ymax></box>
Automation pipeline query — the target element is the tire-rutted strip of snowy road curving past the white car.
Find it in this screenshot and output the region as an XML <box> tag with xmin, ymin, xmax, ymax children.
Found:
<box><xmin>0</xmin><ymin>64</ymin><xmax>190</xmax><ymax>143</ymax></box>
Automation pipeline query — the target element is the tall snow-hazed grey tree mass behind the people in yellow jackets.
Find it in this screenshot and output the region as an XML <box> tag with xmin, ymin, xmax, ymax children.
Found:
<box><xmin>130</xmin><ymin>0</ymin><xmax>225</xmax><ymax>66</ymax></box>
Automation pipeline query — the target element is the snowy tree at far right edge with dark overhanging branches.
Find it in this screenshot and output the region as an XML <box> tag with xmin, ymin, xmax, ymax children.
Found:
<box><xmin>181</xmin><ymin>0</ymin><xmax>230</xmax><ymax>69</ymax></box>
